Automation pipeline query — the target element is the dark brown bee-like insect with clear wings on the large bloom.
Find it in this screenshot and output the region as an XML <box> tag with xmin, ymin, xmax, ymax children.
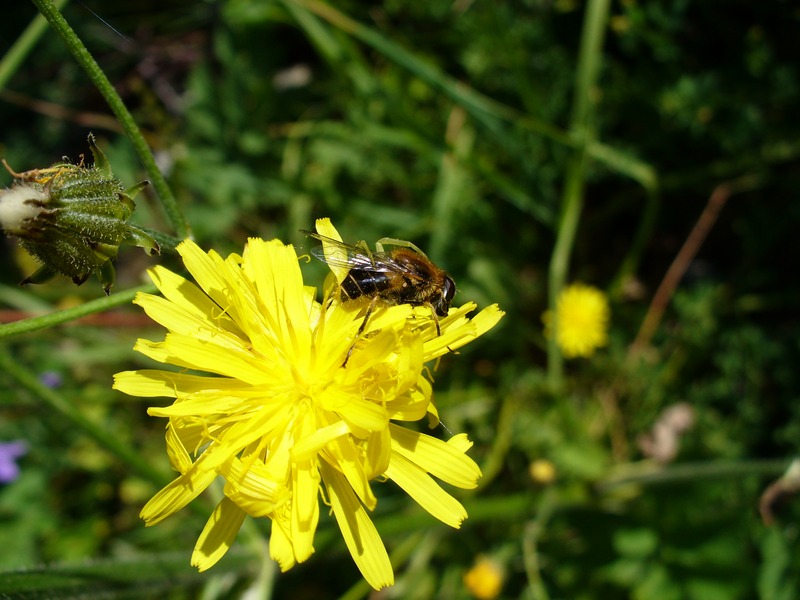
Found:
<box><xmin>303</xmin><ymin>231</ymin><xmax>456</xmax><ymax>356</ymax></box>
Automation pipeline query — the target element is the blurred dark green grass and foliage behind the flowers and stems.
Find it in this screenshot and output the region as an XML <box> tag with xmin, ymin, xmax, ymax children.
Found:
<box><xmin>0</xmin><ymin>0</ymin><xmax>800</xmax><ymax>600</ymax></box>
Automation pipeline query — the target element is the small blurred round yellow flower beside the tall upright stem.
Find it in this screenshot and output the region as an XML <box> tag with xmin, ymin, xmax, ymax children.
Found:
<box><xmin>542</xmin><ymin>283</ymin><xmax>611</xmax><ymax>358</ymax></box>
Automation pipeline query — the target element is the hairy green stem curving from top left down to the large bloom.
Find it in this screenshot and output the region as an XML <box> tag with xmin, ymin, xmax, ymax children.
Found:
<box><xmin>31</xmin><ymin>0</ymin><xmax>190</xmax><ymax>239</ymax></box>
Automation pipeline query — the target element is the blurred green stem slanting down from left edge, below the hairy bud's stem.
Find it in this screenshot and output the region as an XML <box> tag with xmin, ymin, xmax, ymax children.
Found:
<box><xmin>0</xmin><ymin>347</ymin><xmax>169</xmax><ymax>486</ymax></box>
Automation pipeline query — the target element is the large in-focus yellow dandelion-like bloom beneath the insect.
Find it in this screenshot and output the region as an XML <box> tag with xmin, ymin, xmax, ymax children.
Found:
<box><xmin>114</xmin><ymin>220</ymin><xmax>503</xmax><ymax>589</ymax></box>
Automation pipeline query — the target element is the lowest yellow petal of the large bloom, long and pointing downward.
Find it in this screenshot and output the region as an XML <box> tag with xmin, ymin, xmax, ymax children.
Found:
<box><xmin>320</xmin><ymin>461</ymin><xmax>394</xmax><ymax>590</ymax></box>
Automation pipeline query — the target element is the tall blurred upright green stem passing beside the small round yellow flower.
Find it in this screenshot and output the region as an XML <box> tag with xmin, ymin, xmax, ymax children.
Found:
<box><xmin>547</xmin><ymin>0</ymin><xmax>609</xmax><ymax>389</ymax></box>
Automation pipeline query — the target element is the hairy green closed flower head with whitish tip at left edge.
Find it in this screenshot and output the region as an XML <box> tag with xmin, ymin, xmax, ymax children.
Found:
<box><xmin>0</xmin><ymin>134</ymin><xmax>159</xmax><ymax>294</ymax></box>
